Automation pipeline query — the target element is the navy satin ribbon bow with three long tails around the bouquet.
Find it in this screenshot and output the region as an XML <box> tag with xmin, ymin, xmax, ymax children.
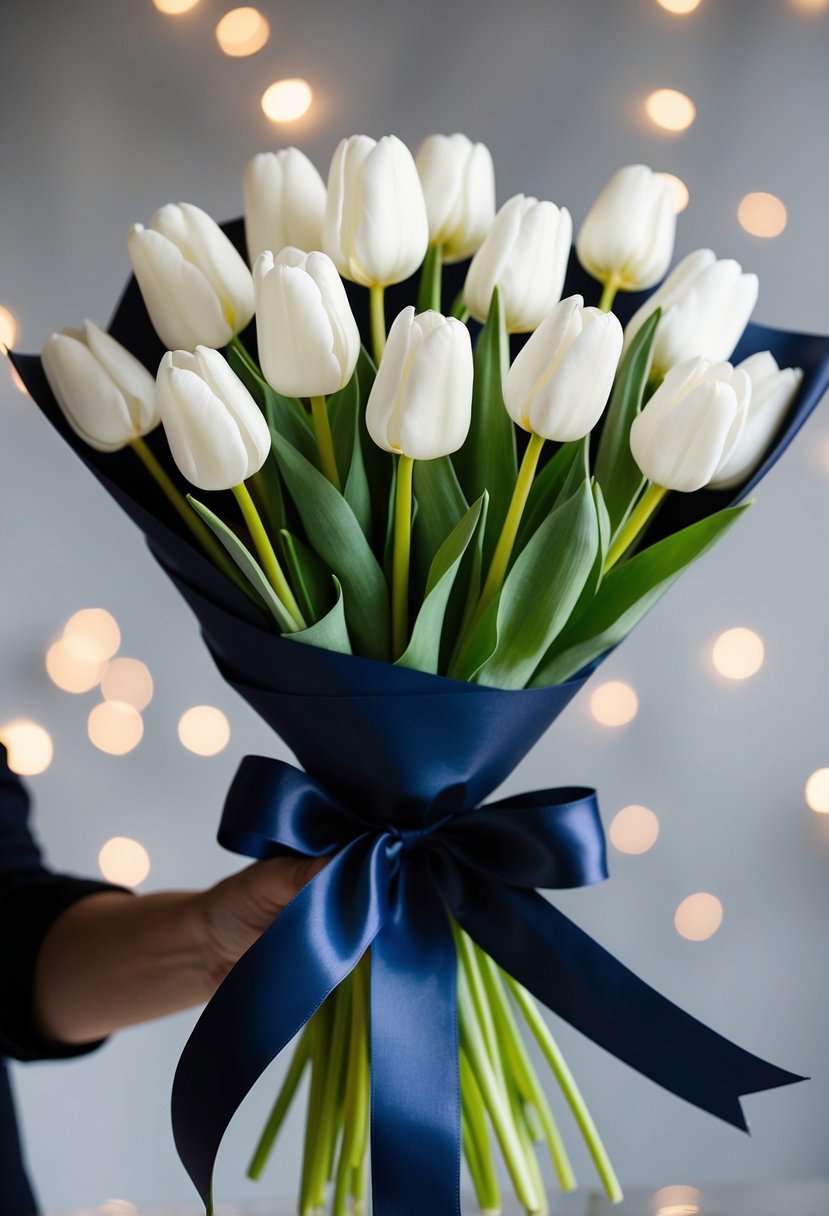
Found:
<box><xmin>173</xmin><ymin>756</ymin><xmax>802</xmax><ymax>1216</ymax></box>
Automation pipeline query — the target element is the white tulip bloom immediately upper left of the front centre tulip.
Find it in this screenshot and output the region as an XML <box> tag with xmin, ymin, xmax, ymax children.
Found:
<box><xmin>253</xmin><ymin>248</ymin><xmax>360</xmax><ymax>396</ymax></box>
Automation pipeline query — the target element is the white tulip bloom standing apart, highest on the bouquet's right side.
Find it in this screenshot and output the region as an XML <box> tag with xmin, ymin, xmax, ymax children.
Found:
<box><xmin>576</xmin><ymin>164</ymin><xmax>676</xmax><ymax>292</ymax></box>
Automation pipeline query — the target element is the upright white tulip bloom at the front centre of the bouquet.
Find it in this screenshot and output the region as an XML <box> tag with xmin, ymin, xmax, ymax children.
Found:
<box><xmin>366</xmin><ymin>305</ymin><xmax>473</xmax><ymax>460</ymax></box>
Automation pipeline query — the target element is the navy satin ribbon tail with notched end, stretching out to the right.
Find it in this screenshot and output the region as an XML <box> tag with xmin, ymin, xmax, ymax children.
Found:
<box><xmin>447</xmin><ymin>874</ymin><xmax>805</xmax><ymax>1131</ymax></box>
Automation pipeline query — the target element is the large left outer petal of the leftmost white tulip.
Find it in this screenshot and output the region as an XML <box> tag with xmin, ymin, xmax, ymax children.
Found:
<box><xmin>41</xmin><ymin>333</ymin><xmax>137</xmax><ymax>452</ymax></box>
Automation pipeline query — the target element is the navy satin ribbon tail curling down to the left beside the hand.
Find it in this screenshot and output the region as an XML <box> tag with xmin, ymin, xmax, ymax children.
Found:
<box><xmin>173</xmin><ymin>837</ymin><xmax>389</xmax><ymax>1212</ymax></box>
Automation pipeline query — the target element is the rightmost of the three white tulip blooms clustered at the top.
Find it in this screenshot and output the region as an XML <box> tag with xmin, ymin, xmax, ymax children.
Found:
<box><xmin>415</xmin><ymin>135</ymin><xmax>495</xmax><ymax>261</ymax></box>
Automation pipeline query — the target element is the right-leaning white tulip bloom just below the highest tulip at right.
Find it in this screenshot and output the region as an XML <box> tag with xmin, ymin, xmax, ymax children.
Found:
<box><xmin>625</xmin><ymin>249</ymin><xmax>758</xmax><ymax>376</ymax></box>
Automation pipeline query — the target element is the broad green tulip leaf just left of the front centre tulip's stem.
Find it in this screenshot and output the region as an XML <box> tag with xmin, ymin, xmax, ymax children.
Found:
<box><xmin>273</xmin><ymin>434</ymin><xmax>389</xmax><ymax>659</ymax></box>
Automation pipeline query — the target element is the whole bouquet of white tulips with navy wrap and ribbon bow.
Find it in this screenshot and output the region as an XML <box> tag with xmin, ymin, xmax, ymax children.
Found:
<box><xmin>17</xmin><ymin>135</ymin><xmax>829</xmax><ymax>1216</ymax></box>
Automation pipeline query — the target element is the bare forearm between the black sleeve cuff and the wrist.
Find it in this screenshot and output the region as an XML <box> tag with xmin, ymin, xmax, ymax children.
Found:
<box><xmin>33</xmin><ymin>891</ymin><xmax>215</xmax><ymax>1043</ymax></box>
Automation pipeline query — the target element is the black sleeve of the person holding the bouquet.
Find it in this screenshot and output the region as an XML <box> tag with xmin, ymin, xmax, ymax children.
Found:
<box><xmin>0</xmin><ymin>743</ymin><xmax>128</xmax><ymax>1060</ymax></box>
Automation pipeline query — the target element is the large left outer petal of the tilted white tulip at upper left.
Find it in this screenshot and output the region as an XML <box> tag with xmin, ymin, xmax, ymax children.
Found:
<box><xmin>128</xmin><ymin>224</ymin><xmax>233</xmax><ymax>350</ymax></box>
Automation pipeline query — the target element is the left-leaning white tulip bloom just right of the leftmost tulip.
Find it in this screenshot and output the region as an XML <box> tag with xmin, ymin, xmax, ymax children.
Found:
<box><xmin>157</xmin><ymin>347</ymin><xmax>271</xmax><ymax>490</ymax></box>
